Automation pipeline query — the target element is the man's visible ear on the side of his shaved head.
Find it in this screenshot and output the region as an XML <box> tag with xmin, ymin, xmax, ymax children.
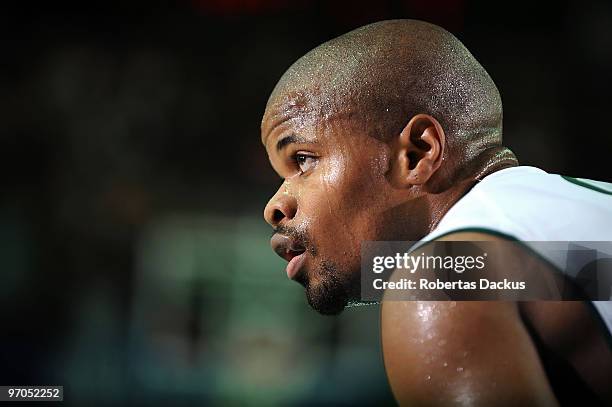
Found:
<box><xmin>391</xmin><ymin>114</ymin><xmax>446</xmax><ymax>187</ymax></box>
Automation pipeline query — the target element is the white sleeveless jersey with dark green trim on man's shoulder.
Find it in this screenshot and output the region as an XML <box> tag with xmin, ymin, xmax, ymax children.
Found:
<box><xmin>422</xmin><ymin>166</ymin><xmax>612</xmax><ymax>333</ymax></box>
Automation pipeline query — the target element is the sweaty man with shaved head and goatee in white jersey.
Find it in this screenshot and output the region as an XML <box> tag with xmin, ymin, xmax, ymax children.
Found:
<box><xmin>262</xmin><ymin>20</ymin><xmax>612</xmax><ymax>405</ymax></box>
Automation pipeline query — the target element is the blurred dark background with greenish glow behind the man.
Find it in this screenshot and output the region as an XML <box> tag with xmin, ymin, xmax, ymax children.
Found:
<box><xmin>0</xmin><ymin>0</ymin><xmax>612</xmax><ymax>405</ymax></box>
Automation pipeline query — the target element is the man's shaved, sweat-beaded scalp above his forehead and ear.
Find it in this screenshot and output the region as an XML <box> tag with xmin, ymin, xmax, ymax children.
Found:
<box><xmin>262</xmin><ymin>20</ymin><xmax>502</xmax><ymax>178</ymax></box>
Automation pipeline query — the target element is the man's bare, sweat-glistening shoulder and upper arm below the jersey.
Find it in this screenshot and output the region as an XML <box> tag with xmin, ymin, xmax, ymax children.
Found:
<box><xmin>381</xmin><ymin>232</ymin><xmax>555</xmax><ymax>405</ymax></box>
